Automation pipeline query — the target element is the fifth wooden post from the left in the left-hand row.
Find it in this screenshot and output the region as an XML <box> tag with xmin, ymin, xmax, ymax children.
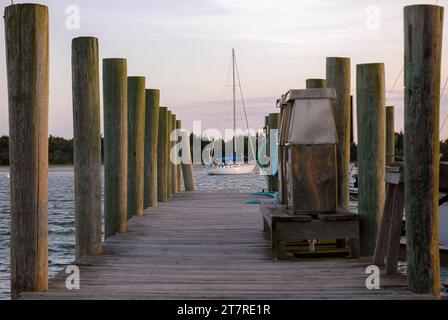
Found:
<box><xmin>144</xmin><ymin>89</ymin><xmax>160</xmax><ymax>208</ymax></box>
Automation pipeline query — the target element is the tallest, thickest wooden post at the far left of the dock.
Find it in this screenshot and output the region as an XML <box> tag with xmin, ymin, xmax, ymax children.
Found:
<box><xmin>4</xmin><ymin>4</ymin><xmax>49</xmax><ymax>299</ymax></box>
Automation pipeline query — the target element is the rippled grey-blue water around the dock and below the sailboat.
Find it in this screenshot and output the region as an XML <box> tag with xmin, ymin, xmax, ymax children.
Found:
<box><xmin>0</xmin><ymin>167</ymin><xmax>448</xmax><ymax>300</ymax></box>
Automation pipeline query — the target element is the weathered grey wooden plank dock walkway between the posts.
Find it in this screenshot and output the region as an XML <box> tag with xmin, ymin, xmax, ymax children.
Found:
<box><xmin>21</xmin><ymin>192</ymin><xmax>432</xmax><ymax>300</ymax></box>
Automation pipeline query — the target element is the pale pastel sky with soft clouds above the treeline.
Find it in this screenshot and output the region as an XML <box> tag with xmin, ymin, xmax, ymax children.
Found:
<box><xmin>0</xmin><ymin>0</ymin><xmax>448</xmax><ymax>138</ymax></box>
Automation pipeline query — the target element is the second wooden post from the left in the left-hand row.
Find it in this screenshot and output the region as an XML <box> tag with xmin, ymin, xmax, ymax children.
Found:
<box><xmin>72</xmin><ymin>37</ymin><xmax>102</xmax><ymax>259</ymax></box>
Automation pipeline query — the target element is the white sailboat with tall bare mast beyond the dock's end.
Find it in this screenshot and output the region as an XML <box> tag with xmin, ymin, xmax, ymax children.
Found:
<box><xmin>206</xmin><ymin>49</ymin><xmax>255</xmax><ymax>175</ymax></box>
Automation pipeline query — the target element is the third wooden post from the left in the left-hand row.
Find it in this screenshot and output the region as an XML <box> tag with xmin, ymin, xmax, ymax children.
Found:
<box><xmin>103</xmin><ymin>59</ymin><xmax>128</xmax><ymax>238</ymax></box>
